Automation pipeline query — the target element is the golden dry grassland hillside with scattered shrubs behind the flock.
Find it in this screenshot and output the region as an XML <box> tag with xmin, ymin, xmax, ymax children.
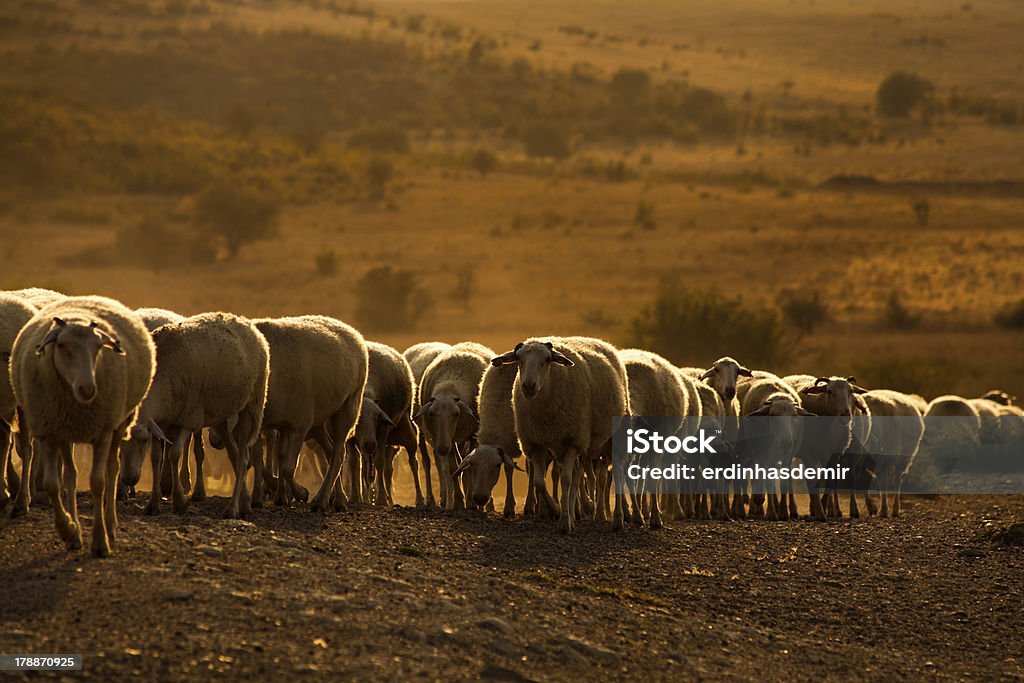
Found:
<box><xmin>0</xmin><ymin>0</ymin><xmax>1024</xmax><ymax>401</ymax></box>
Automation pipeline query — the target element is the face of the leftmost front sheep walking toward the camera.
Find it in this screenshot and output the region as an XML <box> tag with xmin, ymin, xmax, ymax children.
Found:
<box><xmin>36</xmin><ymin>317</ymin><xmax>124</xmax><ymax>403</ymax></box>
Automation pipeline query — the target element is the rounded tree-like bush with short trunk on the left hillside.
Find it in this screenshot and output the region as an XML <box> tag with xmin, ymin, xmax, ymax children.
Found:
<box><xmin>196</xmin><ymin>181</ymin><xmax>281</xmax><ymax>258</ymax></box>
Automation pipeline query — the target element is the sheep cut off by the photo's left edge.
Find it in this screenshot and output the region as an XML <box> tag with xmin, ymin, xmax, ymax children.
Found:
<box><xmin>0</xmin><ymin>293</ymin><xmax>38</xmax><ymax>514</ymax></box>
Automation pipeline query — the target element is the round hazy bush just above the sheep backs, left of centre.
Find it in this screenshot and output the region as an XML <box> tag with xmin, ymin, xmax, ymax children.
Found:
<box><xmin>354</xmin><ymin>265</ymin><xmax>431</xmax><ymax>333</ymax></box>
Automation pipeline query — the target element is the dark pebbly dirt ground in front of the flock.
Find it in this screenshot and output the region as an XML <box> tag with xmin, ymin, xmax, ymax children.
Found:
<box><xmin>0</xmin><ymin>494</ymin><xmax>1024</xmax><ymax>681</ymax></box>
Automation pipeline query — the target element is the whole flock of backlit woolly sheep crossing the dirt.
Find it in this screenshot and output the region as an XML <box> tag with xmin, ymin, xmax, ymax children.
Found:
<box><xmin>0</xmin><ymin>289</ymin><xmax>1024</xmax><ymax>556</ymax></box>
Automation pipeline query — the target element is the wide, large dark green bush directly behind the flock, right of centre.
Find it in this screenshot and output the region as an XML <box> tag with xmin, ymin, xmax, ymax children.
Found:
<box><xmin>624</xmin><ymin>279</ymin><xmax>788</xmax><ymax>367</ymax></box>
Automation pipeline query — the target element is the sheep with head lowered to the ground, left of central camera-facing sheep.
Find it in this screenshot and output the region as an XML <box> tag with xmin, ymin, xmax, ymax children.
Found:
<box><xmin>452</xmin><ymin>364</ymin><xmax>536</xmax><ymax>517</ymax></box>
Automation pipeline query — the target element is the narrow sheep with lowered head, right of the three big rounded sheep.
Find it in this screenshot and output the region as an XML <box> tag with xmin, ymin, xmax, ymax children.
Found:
<box><xmin>354</xmin><ymin>342</ymin><xmax>423</xmax><ymax>506</ymax></box>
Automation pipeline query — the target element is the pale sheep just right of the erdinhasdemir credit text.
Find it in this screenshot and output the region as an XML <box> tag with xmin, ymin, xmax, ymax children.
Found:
<box><xmin>861</xmin><ymin>389</ymin><xmax>925</xmax><ymax>517</ymax></box>
